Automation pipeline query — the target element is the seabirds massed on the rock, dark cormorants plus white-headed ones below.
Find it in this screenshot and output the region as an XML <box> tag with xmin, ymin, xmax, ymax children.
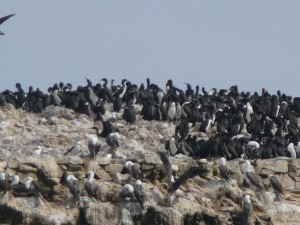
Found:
<box><xmin>0</xmin><ymin>78</ymin><xmax>300</xmax><ymax>221</ymax></box>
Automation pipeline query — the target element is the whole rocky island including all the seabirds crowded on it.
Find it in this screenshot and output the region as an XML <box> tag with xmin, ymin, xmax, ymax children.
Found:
<box><xmin>0</xmin><ymin>78</ymin><xmax>300</xmax><ymax>225</ymax></box>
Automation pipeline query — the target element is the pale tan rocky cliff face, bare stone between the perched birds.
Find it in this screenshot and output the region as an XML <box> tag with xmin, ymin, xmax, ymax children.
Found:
<box><xmin>0</xmin><ymin>104</ymin><xmax>300</xmax><ymax>225</ymax></box>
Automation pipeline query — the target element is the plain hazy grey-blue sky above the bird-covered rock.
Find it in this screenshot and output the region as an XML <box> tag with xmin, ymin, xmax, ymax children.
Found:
<box><xmin>0</xmin><ymin>0</ymin><xmax>300</xmax><ymax>96</ymax></box>
